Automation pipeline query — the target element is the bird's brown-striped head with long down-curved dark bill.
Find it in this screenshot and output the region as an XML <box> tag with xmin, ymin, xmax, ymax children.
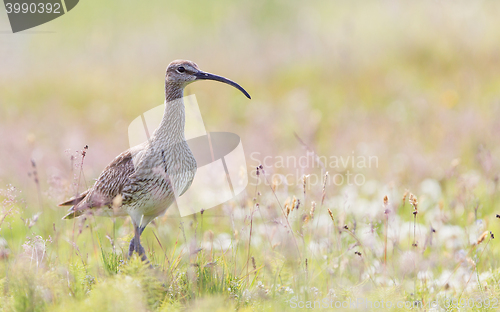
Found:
<box><xmin>165</xmin><ymin>60</ymin><xmax>250</xmax><ymax>99</ymax></box>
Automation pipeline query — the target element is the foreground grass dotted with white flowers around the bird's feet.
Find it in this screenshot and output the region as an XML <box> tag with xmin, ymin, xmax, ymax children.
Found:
<box><xmin>0</xmin><ymin>162</ymin><xmax>500</xmax><ymax>311</ymax></box>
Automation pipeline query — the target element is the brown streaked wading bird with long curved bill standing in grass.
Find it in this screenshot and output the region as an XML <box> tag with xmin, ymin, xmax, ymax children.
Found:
<box><xmin>59</xmin><ymin>60</ymin><xmax>251</xmax><ymax>261</ymax></box>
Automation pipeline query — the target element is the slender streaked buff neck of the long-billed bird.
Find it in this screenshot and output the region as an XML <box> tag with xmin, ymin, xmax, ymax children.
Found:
<box><xmin>153</xmin><ymin>82</ymin><xmax>186</xmax><ymax>144</ymax></box>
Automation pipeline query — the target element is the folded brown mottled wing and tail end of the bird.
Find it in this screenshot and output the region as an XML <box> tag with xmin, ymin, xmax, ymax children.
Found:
<box><xmin>60</xmin><ymin>150</ymin><xmax>134</xmax><ymax>219</ymax></box>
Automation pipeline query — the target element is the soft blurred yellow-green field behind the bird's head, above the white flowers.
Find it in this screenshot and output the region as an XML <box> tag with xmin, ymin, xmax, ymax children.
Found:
<box><xmin>0</xmin><ymin>1</ymin><xmax>500</xmax><ymax>195</ymax></box>
